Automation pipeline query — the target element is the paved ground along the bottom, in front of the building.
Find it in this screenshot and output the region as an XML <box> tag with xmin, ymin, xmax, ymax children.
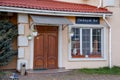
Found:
<box><xmin>19</xmin><ymin>71</ymin><xmax>120</xmax><ymax>80</ymax></box>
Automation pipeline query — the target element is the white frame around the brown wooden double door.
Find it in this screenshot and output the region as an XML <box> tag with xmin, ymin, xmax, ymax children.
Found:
<box><xmin>29</xmin><ymin>24</ymin><xmax>63</xmax><ymax>69</ymax></box>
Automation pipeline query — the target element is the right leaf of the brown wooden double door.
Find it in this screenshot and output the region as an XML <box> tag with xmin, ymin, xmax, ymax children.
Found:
<box><xmin>47</xmin><ymin>33</ymin><xmax>58</xmax><ymax>68</ymax></box>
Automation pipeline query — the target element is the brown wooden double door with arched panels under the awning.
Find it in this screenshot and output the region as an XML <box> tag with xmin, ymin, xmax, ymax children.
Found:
<box><xmin>34</xmin><ymin>26</ymin><xmax>58</xmax><ymax>69</ymax></box>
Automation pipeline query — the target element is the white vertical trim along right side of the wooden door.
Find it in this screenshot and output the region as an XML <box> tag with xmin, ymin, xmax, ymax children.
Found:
<box><xmin>58</xmin><ymin>25</ymin><xmax>63</xmax><ymax>68</ymax></box>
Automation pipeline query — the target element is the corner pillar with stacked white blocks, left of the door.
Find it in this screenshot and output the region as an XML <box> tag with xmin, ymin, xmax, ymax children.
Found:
<box><xmin>17</xmin><ymin>14</ymin><xmax>29</xmax><ymax>71</ymax></box>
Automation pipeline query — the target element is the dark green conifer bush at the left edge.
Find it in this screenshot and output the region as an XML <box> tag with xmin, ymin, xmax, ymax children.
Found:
<box><xmin>0</xmin><ymin>20</ymin><xmax>18</xmax><ymax>66</ymax></box>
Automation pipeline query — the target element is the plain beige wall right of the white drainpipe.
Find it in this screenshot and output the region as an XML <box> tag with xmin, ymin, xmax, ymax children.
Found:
<box><xmin>108</xmin><ymin>0</ymin><xmax>120</xmax><ymax>66</ymax></box>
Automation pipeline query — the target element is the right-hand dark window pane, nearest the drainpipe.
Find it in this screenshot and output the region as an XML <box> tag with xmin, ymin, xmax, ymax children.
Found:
<box><xmin>92</xmin><ymin>29</ymin><xmax>101</xmax><ymax>54</ymax></box>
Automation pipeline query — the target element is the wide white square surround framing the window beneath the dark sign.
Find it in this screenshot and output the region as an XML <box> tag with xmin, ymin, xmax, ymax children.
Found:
<box><xmin>68</xmin><ymin>24</ymin><xmax>107</xmax><ymax>61</ymax></box>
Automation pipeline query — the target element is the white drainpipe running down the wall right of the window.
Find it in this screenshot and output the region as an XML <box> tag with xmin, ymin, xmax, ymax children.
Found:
<box><xmin>103</xmin><ymin>14</ymin><xmax>112</xmax><ymax>68</ymax></box>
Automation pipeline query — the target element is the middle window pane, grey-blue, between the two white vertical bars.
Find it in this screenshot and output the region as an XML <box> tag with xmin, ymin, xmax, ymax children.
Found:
<box><xmin>82</xmin><ymin>29</ymin><xmax>90</xmax><ymax>55</ymax></box>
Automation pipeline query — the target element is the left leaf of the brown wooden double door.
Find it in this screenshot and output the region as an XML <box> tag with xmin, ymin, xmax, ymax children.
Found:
<box><xmin>34</xmin><ymin>33</ymin><xmax>45</xmax><ymax>69</ymax></box>
